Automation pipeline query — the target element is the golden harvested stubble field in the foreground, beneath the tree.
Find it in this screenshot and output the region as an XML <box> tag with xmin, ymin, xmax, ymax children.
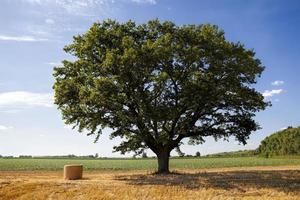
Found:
<box><xmin>0</xmin><ymin>166</ymin><xmax>300</xmax><ymax>200</ymax></box>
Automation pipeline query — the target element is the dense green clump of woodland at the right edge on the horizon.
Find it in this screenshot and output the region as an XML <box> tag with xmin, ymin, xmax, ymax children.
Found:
<box><xmin>258</xmin><ymin>127</ymin><xmax>300</xmax><ymax>157</ymax></box>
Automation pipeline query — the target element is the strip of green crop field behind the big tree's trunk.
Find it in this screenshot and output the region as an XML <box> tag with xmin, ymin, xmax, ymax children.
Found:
<box><xmin>0</xmin><ymin>157</ymin><xmax>300</xmax><ymax>171</ymax></box>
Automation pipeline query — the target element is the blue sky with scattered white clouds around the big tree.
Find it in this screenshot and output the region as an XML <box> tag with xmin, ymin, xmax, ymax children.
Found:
<box><xmin>0</xmin><ymin>0</ymin><xmax>300</xmax><ymax>156</ymax></box>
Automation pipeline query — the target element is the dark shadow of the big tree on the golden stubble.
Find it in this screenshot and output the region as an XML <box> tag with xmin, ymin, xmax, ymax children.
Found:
<box><xmin>115</xmin><ymin>170</ymin><xmax>300</xmax><ymax>195</ymax></box>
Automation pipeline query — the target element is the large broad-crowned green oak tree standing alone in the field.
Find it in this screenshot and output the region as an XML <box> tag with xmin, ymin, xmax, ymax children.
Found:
<box><xmin>54</xmin><ymin>20</ymin><xmax>268</xmax><ymax>173</ymax></box>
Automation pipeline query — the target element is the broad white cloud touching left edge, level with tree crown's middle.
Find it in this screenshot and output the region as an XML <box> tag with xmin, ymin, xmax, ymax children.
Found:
<box><xmin>0</xmin><ymin>91</ymin><xmax>54</xmax><ymax>110</ymax></box>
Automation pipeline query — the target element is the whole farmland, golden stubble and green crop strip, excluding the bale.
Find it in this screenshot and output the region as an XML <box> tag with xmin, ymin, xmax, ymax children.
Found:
<box><xmin>0</xmin><ymin>157</ymin><xmax>300</xmax><ymax>200</ymax></box>
